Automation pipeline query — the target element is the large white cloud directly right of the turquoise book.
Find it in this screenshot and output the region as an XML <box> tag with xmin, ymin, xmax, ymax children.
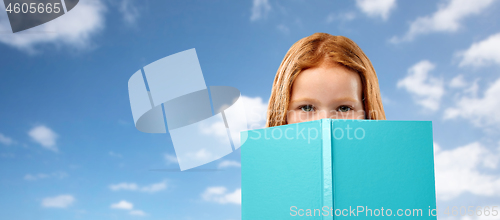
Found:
<box><xmin>434</xmin><ymin>142</ymin><xmax>500</xmax><ymax>201</ymax></box>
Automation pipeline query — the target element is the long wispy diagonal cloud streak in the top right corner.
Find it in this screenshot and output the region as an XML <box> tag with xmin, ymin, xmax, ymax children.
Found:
<box><xmin>391</xmin><ymin>0</ymin><xmax>494</xmax><ymax>43</ymax></box>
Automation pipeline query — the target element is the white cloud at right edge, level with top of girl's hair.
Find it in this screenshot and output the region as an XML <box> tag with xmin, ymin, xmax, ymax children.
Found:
<box><xmin>457</xmin><ymin>33</ymin><xmax>500</xmax><ymax>67</ymax></box>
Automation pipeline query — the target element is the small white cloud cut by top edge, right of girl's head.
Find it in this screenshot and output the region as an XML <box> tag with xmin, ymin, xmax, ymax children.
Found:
<box><xmin>356</xmin><ymin>0</ymin><xmax>396</xmax><ymax>20</ymax></box>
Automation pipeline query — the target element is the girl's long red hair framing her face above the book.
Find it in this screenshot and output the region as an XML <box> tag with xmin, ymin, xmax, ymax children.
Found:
<box><xmin>266</xmin><ymin>33</ymin><xmax>386</xmax><ymax>127</ymax></box>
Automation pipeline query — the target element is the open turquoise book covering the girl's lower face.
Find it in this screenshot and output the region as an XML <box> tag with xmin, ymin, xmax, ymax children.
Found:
<box><xmin>241</xmin><ymin>119</ymin><xmax>437</xmax><ymax>220</ymax></box>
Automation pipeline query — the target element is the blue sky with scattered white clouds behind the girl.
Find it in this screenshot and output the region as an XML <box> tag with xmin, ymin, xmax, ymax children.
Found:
<box><xmin>0</xmin><ymin>0</ymin><xmax>500</xmax><ymax>220</ymax></box>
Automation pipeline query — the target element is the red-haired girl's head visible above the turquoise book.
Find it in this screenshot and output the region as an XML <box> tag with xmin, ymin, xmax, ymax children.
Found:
<box><xmin>266</xmin><ymin>33</ymin><xmax>385</xmax><ymax>127</ymax></box>
